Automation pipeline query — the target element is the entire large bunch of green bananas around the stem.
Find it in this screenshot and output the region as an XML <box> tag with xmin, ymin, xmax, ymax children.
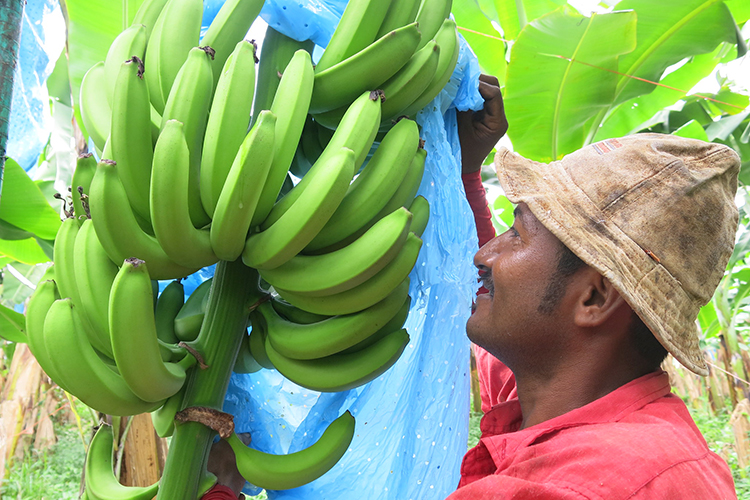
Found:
<box><xmin>27</xmin><ymin>0</ymin><xmax>459</xmax><ymax>499</ymax></box>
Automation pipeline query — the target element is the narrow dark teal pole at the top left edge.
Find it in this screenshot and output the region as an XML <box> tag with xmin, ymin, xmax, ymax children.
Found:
<box><xmin>0</xmin><ymin>0</ymin><xmax>25</xmax><ymax>197</ymax></box>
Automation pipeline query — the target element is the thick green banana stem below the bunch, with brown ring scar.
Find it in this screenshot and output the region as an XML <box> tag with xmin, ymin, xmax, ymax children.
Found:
<box><xmin>156</xmin><ymin>259</ymin><xmax>261</xmax><ymax>500</ymax></box>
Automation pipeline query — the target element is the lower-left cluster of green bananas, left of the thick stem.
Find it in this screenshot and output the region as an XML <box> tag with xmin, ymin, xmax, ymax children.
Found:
<box><xmin>26</xmin><ymin>218</ymin><xmax>196</xmax><ymax>415</ymax></box>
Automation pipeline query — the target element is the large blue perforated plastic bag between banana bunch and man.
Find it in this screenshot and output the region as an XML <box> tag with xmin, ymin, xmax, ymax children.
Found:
<box><xmin>212</xmin><ymin>0</ymin><xmax>483</xmax><ymax>500</ymax></box>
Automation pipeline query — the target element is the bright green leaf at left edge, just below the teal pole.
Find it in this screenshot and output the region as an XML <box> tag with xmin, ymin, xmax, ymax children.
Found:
<box><xmin>0</xmin><ymin>158</ymin><xmax>60</xmax><ymax>240</ymax></box>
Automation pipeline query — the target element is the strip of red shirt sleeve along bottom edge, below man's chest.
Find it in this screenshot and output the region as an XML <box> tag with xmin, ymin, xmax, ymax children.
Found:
<box><xmin>446</xmin><ymin>475</ymin><xmax>590</xmax><ymax>500</ymax></box>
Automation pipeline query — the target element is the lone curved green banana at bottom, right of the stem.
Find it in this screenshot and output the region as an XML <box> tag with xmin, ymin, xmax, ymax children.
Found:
<box><xmin>227</xmin><ymin>411</ymin><xmax>355</xmax><ymax>490</ymax></box>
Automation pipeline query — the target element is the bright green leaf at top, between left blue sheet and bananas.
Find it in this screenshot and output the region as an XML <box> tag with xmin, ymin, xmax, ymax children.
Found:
<box><xmin>60</xmin><ymin>0</ymin><xmax>143</xmax><ymax>123</ymax></box>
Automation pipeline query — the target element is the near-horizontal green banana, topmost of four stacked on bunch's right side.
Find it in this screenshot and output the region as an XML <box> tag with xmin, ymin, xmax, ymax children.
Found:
<box><xmin>261</xmin><ymin>208</ymin><xmax>411</xmax><ymax>296</ymax></box>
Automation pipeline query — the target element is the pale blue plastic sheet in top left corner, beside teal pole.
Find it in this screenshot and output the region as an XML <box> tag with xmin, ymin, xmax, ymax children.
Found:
<box><xmin>6</xmin><ymin>0</ymin><xmax>65</xmax><ymax>171</ymax></box>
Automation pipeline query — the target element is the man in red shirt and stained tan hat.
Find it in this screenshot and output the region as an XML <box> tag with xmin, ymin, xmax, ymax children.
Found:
<box><xmin>449</xmin><ymin>77</ymin><xmax>739</xmax><ymax>500</ymax></box>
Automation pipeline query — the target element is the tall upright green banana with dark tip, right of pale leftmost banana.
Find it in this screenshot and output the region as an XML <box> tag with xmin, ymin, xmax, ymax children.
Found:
<box><xmin>109</xmin><ymin>57</ymin><xmax>153</xmax><ymax>223</ymax></box>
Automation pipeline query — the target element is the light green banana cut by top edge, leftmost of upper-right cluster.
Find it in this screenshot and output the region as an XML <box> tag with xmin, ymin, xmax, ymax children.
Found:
<box><xmin>315</xmin><ymin>0</ymin><xmax>392</xmax><ymax>73</ymax></box>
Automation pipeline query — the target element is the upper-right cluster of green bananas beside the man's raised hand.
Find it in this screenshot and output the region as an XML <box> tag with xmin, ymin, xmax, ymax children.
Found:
<box><xmin>310</xmin><ymin>0</ymin><xmax>459</xmax><ymax>129</ymax></box>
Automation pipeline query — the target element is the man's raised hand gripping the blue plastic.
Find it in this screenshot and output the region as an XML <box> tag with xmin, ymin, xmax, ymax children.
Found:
<box><xmin>457</xmin><ymin>75</ymin><xmax>508</xmax><ymax>174</ymax></box>
